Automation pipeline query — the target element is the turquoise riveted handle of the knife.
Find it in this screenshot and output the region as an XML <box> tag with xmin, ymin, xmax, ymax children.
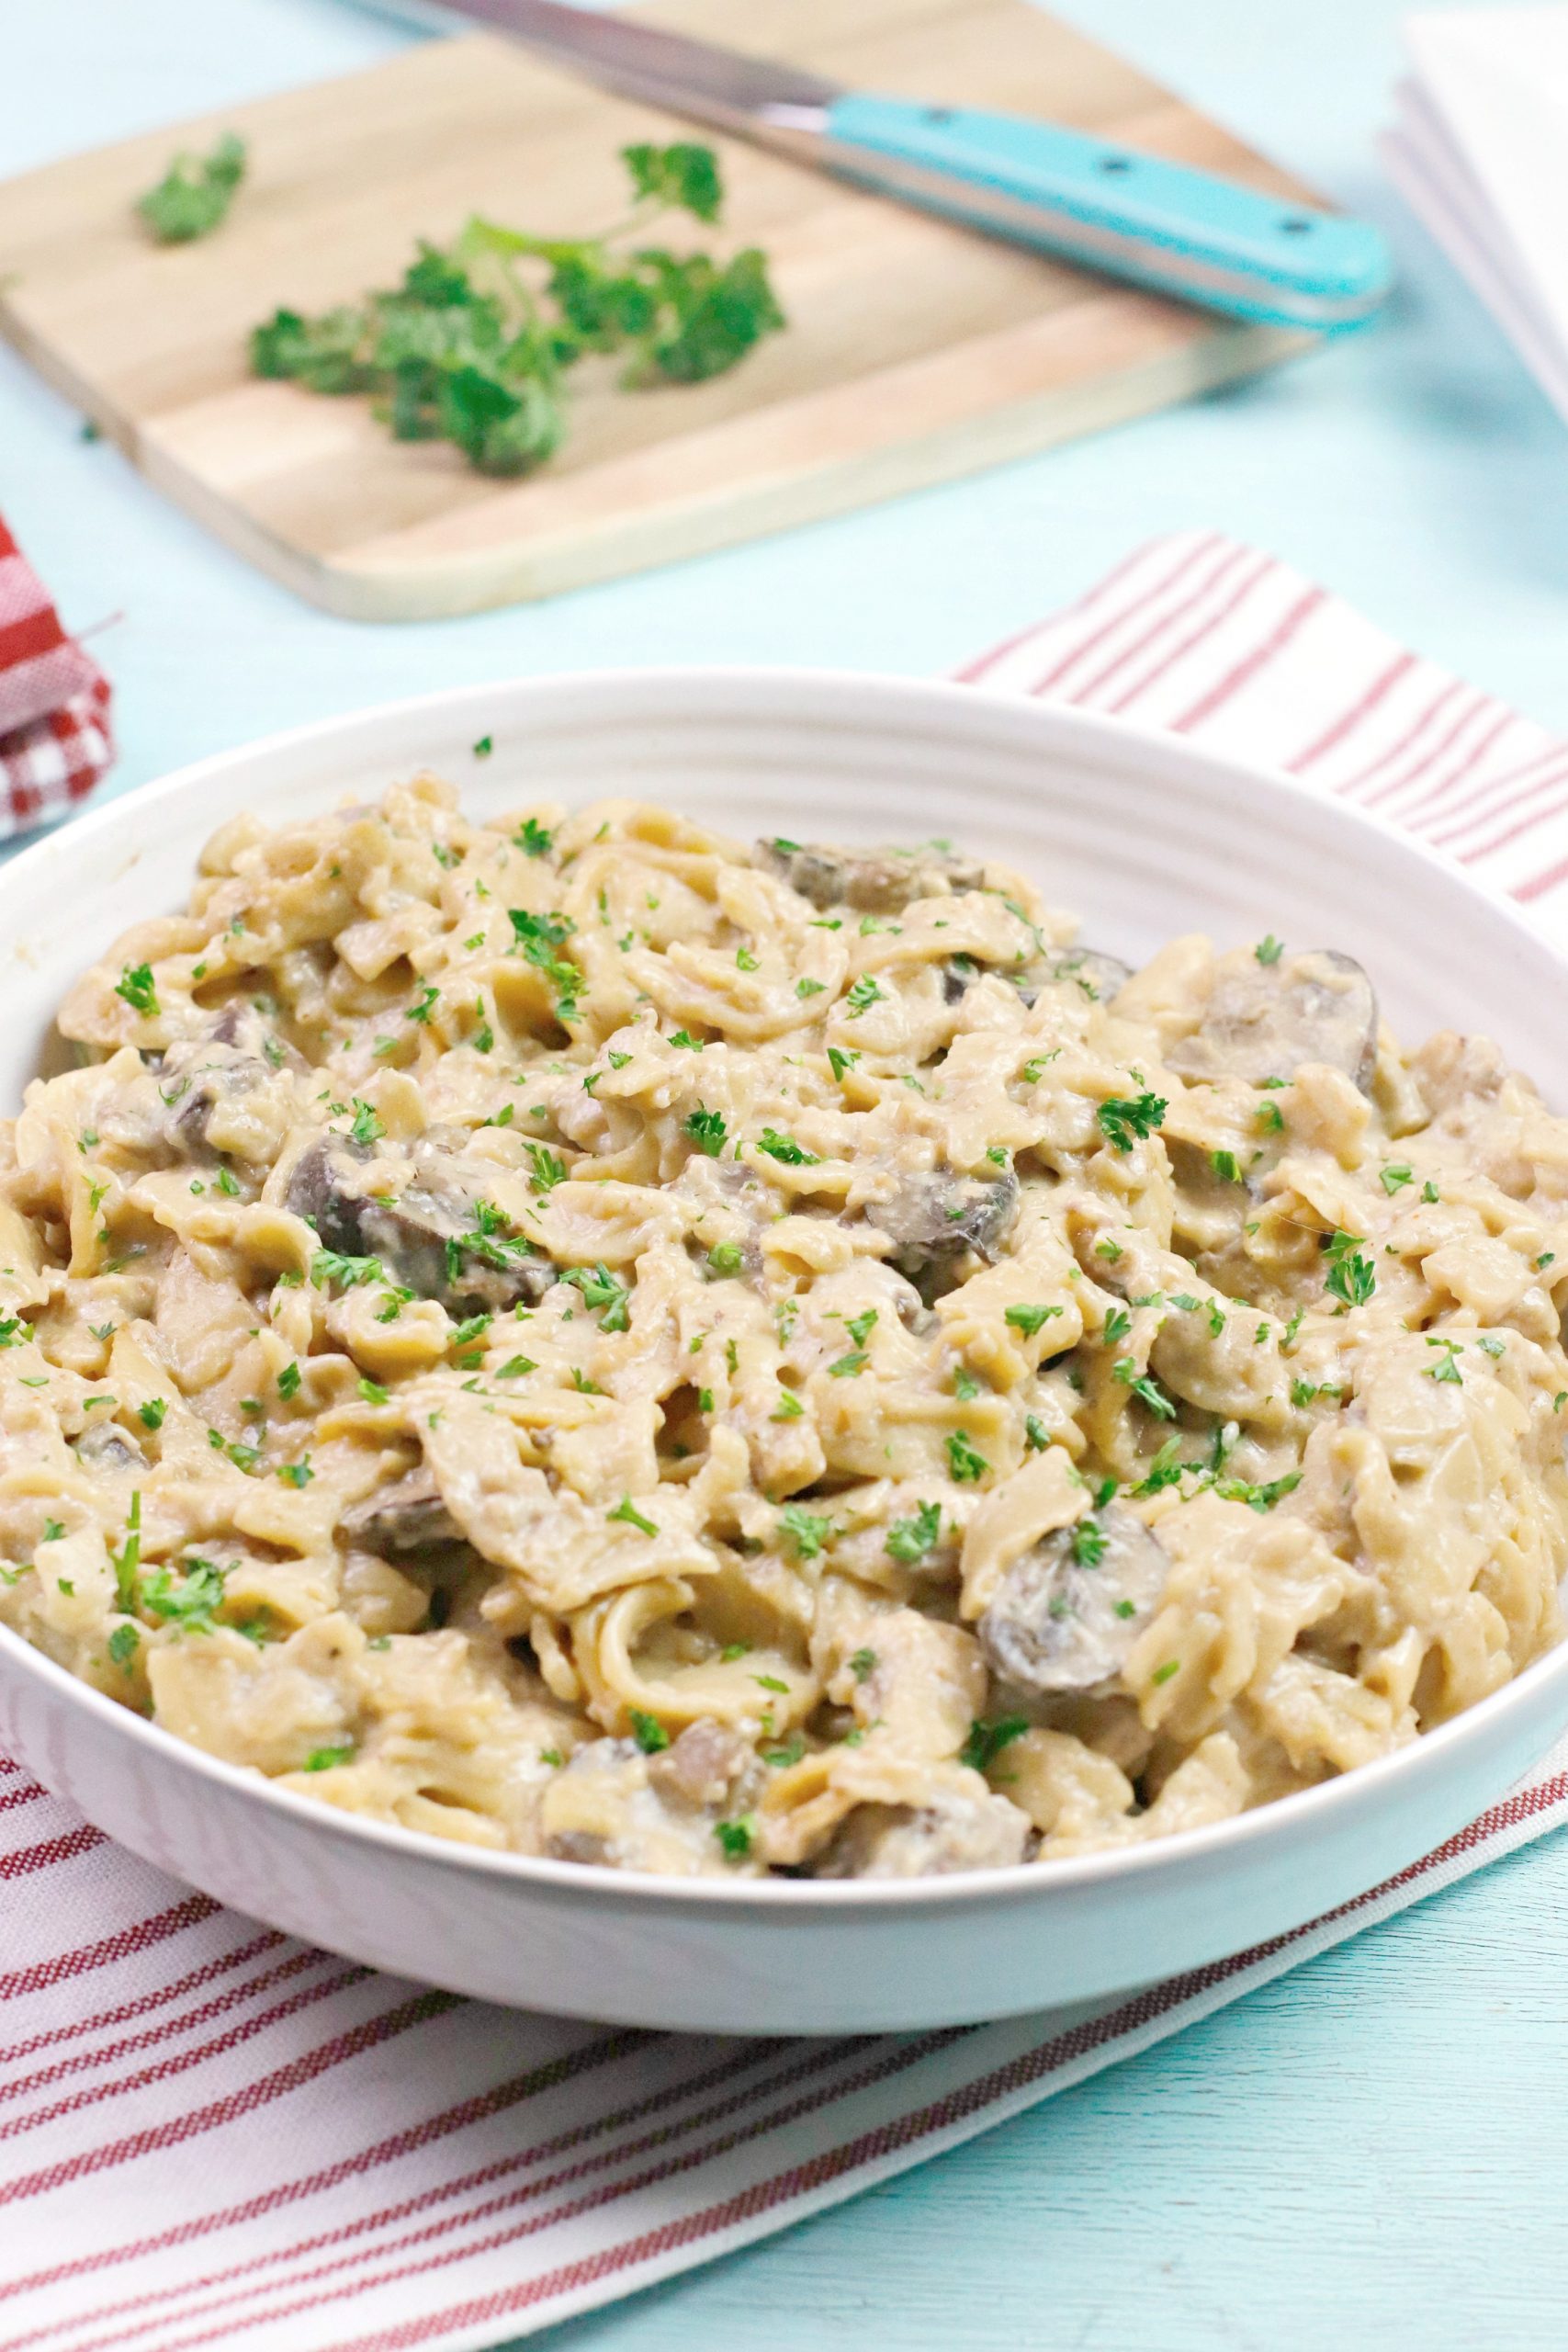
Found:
<box><xmin>823</xmin><ymin>96</ymin><xmax>1392</xmax><ymax>329</ymax></box>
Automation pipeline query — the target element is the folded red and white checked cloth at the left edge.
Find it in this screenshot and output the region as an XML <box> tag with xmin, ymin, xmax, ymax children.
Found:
<box><xmin>0</xmin><ymin>520</ymin><xmax>115</xmax><ymax>840</ymax></box>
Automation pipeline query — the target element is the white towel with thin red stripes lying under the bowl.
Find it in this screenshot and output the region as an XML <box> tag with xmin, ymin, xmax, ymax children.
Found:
<box><xmin>0</xmin><ymin>537</ymin><xmax>1568</xmax><ymax>2352</ymax></box>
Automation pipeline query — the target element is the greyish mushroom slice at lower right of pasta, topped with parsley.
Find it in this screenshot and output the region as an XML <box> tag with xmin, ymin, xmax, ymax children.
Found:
<box><xmin>978</xmin><ymin>1503</ymin><xmax>1170</xmax><ymax>1691</ymax></box>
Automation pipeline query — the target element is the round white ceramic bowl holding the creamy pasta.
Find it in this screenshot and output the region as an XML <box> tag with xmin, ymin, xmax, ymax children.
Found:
<box><xmin>0</xmin><ymin>671</ymin><xmax>1568</xmax><ymax>2032</ymax></box>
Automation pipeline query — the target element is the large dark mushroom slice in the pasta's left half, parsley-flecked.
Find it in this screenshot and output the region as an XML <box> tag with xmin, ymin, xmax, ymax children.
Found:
<box><xmin>287</xmin><ymin>1134</ymin><xmax>555</xmax><ymax>1315</ymax></box>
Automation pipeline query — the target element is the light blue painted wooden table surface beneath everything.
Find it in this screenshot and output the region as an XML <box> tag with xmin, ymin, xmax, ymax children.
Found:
<box><xmin>0</xmin><ymin>0</ymin><xmax>1568</xmax><ymax>2352</ymax></box>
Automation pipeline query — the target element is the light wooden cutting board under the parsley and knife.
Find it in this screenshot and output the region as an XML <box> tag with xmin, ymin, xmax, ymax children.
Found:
<box><xmin>0</xmin><ymin>0</ymin><xmax>1307</xmax><ymax>621</ymax></box>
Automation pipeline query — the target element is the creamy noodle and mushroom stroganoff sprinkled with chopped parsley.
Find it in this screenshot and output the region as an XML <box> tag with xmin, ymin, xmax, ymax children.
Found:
<box><xmin>0</xmin><ymin>778</ymin><xmax>1568</xmax><ymax>1877</ymax></box>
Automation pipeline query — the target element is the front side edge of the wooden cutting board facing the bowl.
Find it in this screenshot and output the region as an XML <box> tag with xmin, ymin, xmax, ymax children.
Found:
<box><xmin>125</xmin><ymin>327</ymin><xmax>1321</xmax><ymax>623</ymax></box>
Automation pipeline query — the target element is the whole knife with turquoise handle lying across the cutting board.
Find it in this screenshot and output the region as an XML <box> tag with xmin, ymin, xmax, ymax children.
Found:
<box><xmin>350</xmin><ymin>0</ymin><xmax>1392</xmax><ymax>332</ymax></box>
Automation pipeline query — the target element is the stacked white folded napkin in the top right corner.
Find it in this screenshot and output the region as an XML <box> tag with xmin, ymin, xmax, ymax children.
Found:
<box><xmin>1380</xmin><ymin>7</ymin><xmax>1568</xmax><ymax>419</ymax></box>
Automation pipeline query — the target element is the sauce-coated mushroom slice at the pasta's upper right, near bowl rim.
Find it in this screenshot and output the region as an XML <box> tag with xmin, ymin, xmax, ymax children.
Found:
<box><xmin>1166</xmin><ymin>948</ymin><xmax>1378</xmax><ymax>1091</ymax></box>
